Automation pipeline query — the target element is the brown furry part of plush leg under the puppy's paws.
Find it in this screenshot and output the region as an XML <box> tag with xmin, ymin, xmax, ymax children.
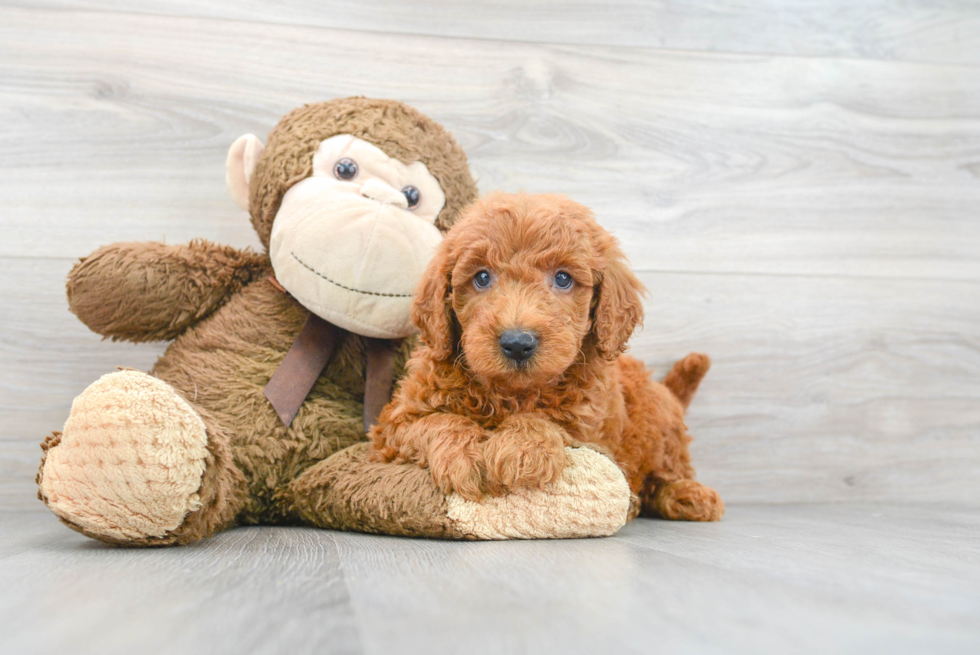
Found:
<box><xmin>288</xmin><ymin>443</ymin><xmax>466</xmax><ymax>539</ymax></box>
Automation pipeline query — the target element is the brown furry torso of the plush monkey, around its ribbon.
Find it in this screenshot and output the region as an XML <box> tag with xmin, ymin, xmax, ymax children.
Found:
<box><xmin>153</xmin><ymin>280</ymin><xmax>411</xmax><ymax>523</ymax></box>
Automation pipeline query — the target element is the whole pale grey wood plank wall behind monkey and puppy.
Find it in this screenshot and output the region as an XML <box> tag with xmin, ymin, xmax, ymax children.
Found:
<box><xmin>0</xmin><ymin>0</ymin><xmax>980</xmax><ymax>508</ymax></box>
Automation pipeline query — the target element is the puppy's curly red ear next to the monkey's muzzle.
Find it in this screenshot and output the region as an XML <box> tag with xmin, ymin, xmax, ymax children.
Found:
<box><xmin>412</xmin><ymin>241</ymin><xmax>455</xmax><ymax>359</ymax></box>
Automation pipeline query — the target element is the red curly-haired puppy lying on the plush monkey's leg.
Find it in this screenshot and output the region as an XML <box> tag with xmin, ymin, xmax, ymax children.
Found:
<box><xmin>371</xmin><ymin>194</ymin><xmax>724</xmax><ymax>521</ymax></box>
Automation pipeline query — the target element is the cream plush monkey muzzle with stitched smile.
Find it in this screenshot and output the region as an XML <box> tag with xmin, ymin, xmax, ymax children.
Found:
<box><xmin>269</xmin><ymin>177</ymin><xmax>442</xmax><ymax>339</ymax></box>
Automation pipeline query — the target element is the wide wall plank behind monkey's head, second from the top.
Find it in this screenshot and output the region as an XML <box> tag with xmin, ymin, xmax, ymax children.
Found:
<box><xmin>0</xmin><ymin>7</ymin><xmax>980</xmax><ymax>280</ymax></box>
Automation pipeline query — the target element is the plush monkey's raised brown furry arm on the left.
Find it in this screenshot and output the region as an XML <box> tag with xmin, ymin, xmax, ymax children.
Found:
<box><xmin>67</xmin><ymin>240</ymin><xmax>271</xmax><ymax>342</ymax></box>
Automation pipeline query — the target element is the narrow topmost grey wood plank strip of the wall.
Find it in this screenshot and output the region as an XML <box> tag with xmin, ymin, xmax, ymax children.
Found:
<box><xmin>14</xmin><ymin>0</ymin><xmax>980</xmax><ymax>64</ymax></box>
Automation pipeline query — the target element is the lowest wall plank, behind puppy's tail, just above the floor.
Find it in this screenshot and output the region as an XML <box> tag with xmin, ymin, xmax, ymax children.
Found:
<box><xmin>0</xmin><ymin>259</ymin><xmax>980</xmax><ymax>507</ymax></box>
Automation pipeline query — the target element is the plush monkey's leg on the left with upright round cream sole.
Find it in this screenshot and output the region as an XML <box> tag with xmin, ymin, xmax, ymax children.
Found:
<box><xmin>37</xmin><ymin>371</ymin><xmax>245</xmax><ymax>546</ymax></box>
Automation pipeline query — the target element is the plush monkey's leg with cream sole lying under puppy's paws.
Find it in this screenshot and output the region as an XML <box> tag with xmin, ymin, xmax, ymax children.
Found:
<box><xmin>289</xmin><ymin>443</ymin><xmax>638</xmax><ymax>539</ymax></box>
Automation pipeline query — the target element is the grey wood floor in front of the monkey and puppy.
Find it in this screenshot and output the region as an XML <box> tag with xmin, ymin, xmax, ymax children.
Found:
<box><xmin>0</xmin><ymin>504</ymin><xmax>980</xmax><ymax>655</ymax></box>
